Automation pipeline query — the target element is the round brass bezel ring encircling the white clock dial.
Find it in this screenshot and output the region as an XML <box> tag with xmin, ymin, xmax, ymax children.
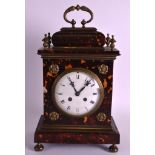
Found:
<box><xmin>51</xmin><ymin>68</ymin><xmax>104</xmax><ymax>118</ymax></box>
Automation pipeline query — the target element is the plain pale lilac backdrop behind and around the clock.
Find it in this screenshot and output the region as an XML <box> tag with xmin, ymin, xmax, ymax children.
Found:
<box><xmin>25</xmin><ymin>0</ymin><xmax>130</xmax><ymax>155</ymax></box>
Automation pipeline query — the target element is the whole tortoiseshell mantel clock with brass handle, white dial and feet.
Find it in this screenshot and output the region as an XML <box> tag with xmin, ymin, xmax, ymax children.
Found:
<box><xmin>34</xmin><ymin>5</ymin><xmax>120</xmax><ymax>152</ymax></box>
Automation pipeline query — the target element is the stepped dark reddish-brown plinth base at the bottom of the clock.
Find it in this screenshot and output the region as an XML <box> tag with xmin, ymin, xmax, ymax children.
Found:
<box><xmin>34</xmin><ymin>116</ymin><xmax>120</xmax><ymax>148</ymax></box>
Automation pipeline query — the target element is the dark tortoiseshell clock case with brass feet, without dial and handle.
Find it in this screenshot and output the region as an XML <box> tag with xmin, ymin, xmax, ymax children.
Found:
<box><xmin>34</xmin><ymin>6</ymin><xmax>120</xmax><ymax>152</ymax></box>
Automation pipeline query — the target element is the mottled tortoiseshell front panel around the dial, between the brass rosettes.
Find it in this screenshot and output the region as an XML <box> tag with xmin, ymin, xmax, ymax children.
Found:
<box><xmin>43</xmin><ymin>58</ymin><xmax>113</xmax><ymax>125</ymax></box>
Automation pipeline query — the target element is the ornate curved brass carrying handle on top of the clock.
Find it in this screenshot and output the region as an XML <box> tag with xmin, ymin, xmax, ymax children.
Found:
<box><xmin>63</xmin><ymin>5</ymin><xmax>93</xmax><ymax>28</ymax></box>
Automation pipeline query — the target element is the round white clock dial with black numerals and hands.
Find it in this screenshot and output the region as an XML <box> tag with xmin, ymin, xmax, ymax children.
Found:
<box><xmin>52</xmin><ymin>68</ymin><xmax>103</xmax><ymax>116</ymax></box>
